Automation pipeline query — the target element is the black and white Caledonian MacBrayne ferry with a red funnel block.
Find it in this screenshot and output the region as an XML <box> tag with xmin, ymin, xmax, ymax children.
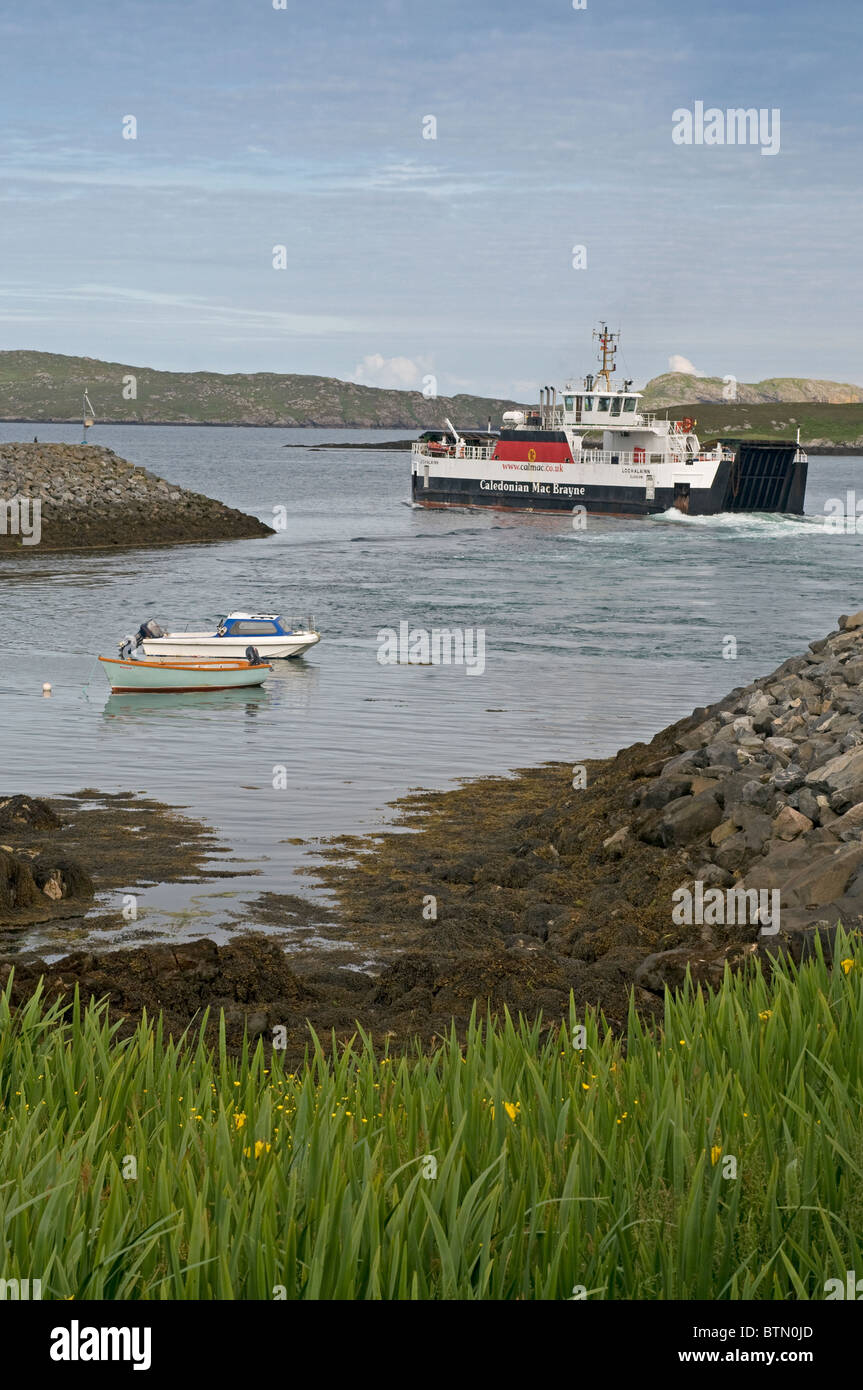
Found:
<box><xmin>411</xmin><ymin>324</ymin><xmax>807</xmax><ymax>517</ymax></box>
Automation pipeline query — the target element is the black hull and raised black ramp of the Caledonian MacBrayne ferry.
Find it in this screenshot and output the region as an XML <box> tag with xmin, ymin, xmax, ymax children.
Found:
<box><xmin>411</xmin><ymin>443</ymin><xmax>807</xmax><ymax>517</ymax></box>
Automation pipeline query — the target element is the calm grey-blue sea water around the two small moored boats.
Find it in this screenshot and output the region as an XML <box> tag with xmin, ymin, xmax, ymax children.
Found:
<box><xmin>0</xmin><ymin>424</ymin><xmax>863</xmax><ymax>935</ymax></box>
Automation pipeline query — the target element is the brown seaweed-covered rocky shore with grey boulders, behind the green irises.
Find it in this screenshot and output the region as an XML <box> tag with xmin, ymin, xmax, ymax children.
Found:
<box><xmin>0</xmin><ymin>612</ymin><xmax>863</xmax><ymax>1056</ymax></box>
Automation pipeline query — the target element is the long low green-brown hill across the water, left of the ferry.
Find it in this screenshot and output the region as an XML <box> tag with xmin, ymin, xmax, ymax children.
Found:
<box><xmin>0</xmin><ymin>352</ymin><xmax>517</xmax><ymax>430</ymax></box>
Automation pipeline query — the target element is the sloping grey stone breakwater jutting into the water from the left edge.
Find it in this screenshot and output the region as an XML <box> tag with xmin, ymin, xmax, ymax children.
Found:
<box><xmin>0</xmin><ymin>443</ymin><xmax>272</xmax><ymax>555</ymax></box>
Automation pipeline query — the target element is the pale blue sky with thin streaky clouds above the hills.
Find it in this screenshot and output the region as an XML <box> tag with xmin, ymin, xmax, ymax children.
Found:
<box><xmin>0</xmin><ymin>0</ymin><xmax>863</xmax><ymax>400</ymax></box>
